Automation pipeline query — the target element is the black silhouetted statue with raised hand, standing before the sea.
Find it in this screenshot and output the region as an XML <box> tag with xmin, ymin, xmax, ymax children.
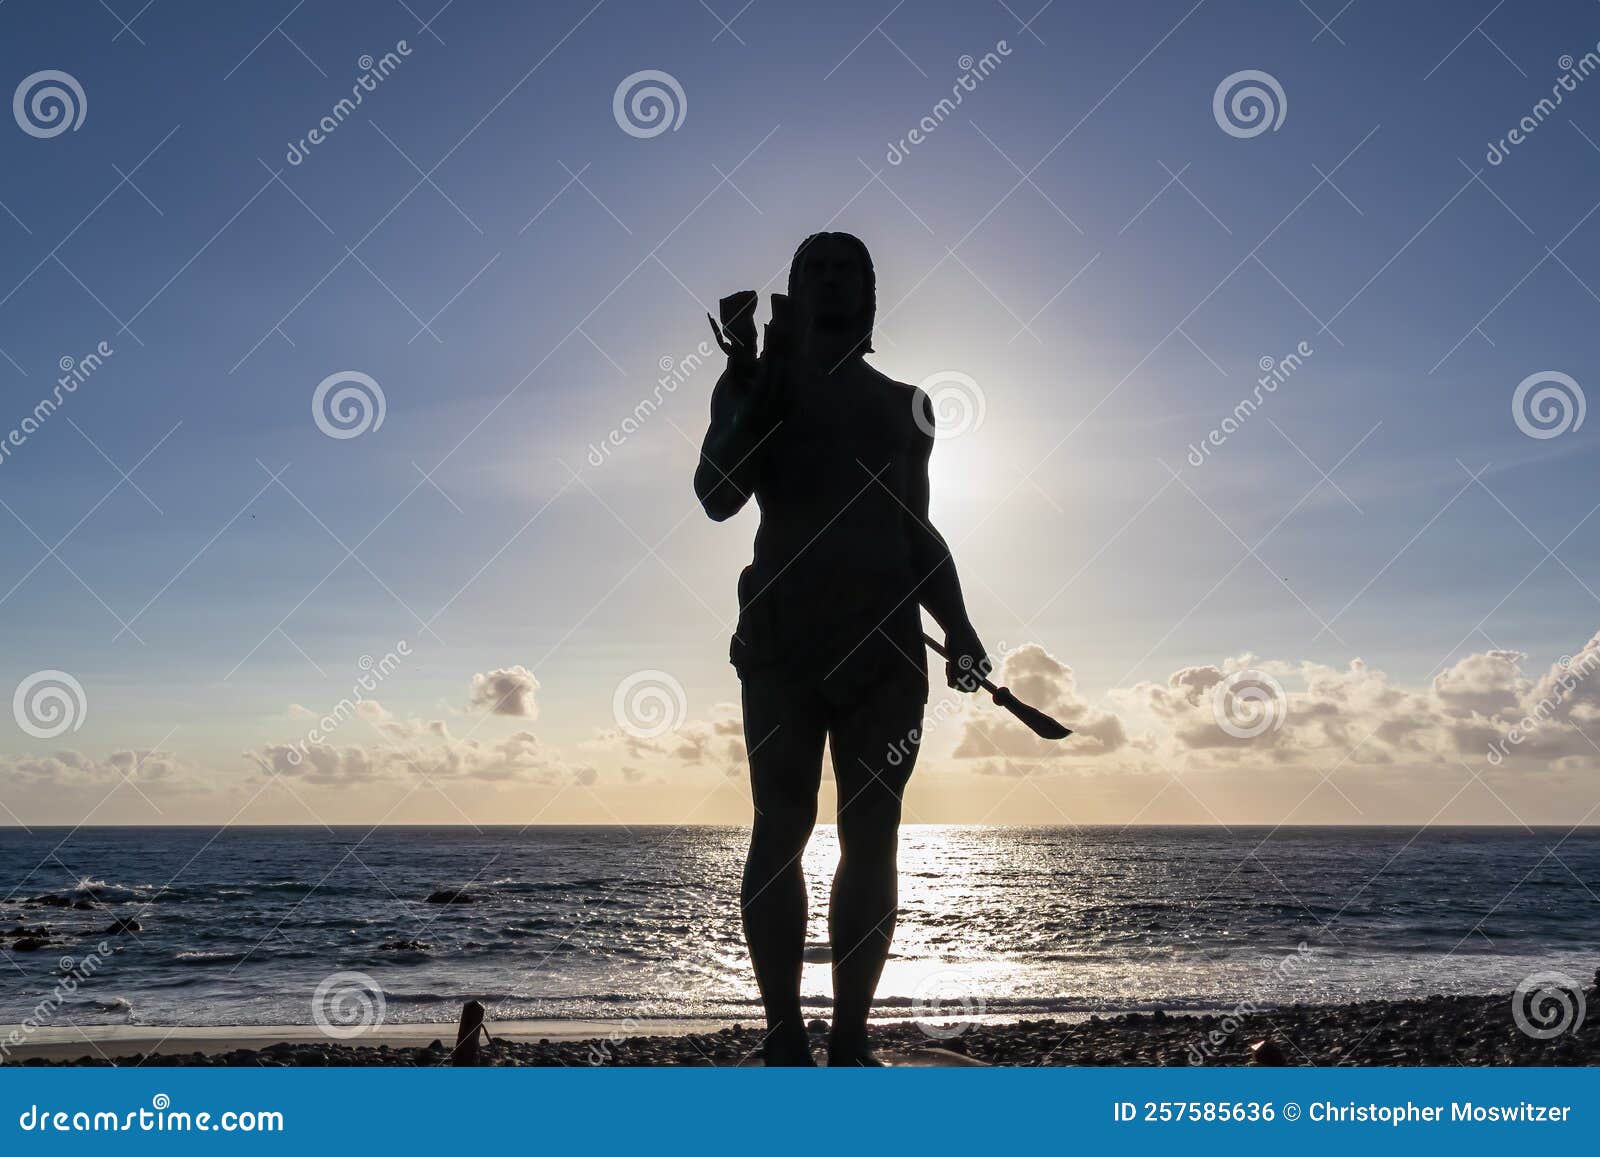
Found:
<box><xmin>694</xmin><ymin>234</ymin><xmax>990</xmax><ymax>1066</ymax></box>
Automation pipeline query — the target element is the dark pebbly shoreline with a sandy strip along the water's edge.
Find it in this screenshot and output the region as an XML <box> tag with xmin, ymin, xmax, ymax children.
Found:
<box><xmin>0</xmin><ymin>987</ymin><xmax>1600</xmax><ymax>1067</ymax></box>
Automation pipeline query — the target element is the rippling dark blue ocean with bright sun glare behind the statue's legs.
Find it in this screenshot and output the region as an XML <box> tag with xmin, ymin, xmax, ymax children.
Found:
<box><xmin>0</xmin><ymin>826</ymin><xmax>1600</xmax><ymax>1026</ymax></box>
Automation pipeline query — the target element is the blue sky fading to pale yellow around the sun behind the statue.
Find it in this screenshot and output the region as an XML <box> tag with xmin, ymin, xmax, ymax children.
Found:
<box><xmin>0</xmin><ymin>0</ymin><xmax>1600</xmax><ymax>826</ymax></box>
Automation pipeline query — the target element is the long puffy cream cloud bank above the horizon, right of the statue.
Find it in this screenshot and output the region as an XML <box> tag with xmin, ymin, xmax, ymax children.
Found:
<box><xmin>954</xmin><ymin>634</ymin><xmax>1600</xmax><ymax>775</ymax></box>
